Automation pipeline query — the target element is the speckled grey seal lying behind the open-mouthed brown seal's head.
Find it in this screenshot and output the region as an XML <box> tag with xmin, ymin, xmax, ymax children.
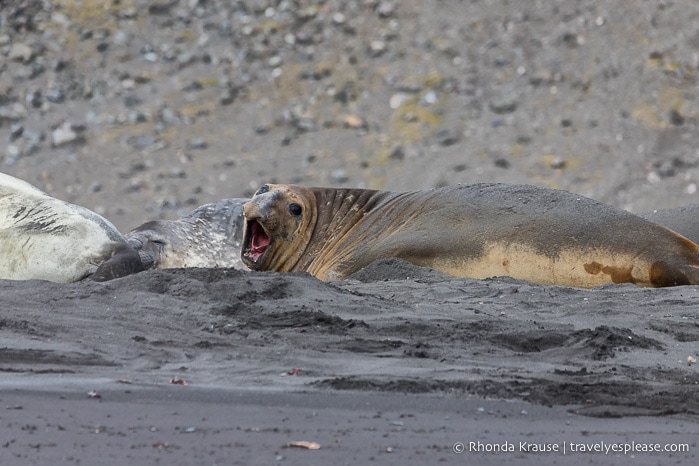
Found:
<box><xmin>126</xmin><ymin>199</ymin><xmax>247</xmax><ymax>269</ymax></box>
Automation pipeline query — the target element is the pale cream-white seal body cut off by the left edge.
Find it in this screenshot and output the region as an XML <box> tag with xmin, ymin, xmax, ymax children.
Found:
<box><xmin>0</xmin><ymin>173</ymin><xmax>143</xmax><ymax>283</ymax></box>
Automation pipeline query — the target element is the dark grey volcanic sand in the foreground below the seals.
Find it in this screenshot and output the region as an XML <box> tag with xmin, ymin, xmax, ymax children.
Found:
<box><xmin>0</xmin><ymin>260</ymin><xmax>699</xmax><ymax>464</ymax></box>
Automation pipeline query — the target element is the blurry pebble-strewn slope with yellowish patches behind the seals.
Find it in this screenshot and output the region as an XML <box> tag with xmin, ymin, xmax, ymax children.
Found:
<box><xmin>0</xmin><ymin>0</ymin><xmax>699</xmax><ymax>231</ymax></box>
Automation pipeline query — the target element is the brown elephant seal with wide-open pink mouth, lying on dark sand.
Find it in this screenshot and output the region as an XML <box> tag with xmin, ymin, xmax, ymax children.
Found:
<box><xmin>242</xmin><ymin>184</ymin><xmax>699</xmax><ymax>287</ymax></box>
